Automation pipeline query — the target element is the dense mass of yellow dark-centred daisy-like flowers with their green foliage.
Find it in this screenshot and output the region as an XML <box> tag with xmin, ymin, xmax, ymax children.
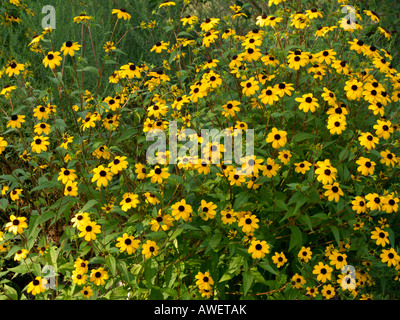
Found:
<box><xmin>0</xmin><ymin>0</ymin><xmax>400</xmax><ymax>299</ymax></box>
